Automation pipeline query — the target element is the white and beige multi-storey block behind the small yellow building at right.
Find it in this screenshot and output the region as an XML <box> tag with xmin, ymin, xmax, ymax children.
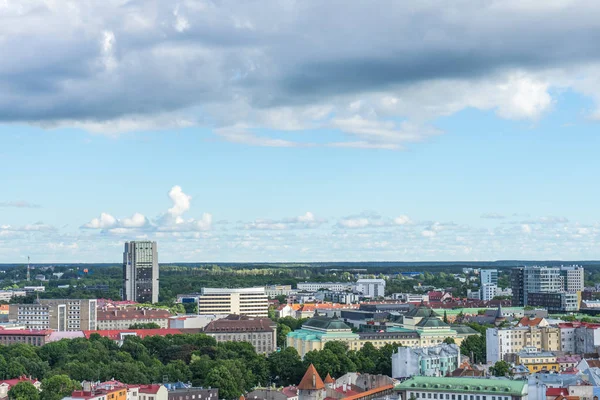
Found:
<box><xmin>485</xmin><ymin>326</ymin><xmax>561</xmax><ymax>363</ymax></box>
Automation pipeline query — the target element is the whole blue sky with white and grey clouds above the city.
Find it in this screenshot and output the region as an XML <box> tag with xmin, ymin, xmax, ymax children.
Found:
<box><xmin>0</xmin><ymin>0</ymin><xmax>600</xmax><ymax>263</ymax></box>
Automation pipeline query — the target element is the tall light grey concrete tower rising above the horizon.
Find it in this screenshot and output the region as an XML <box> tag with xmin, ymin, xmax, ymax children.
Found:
<box><xmin>123</xmin><ymin>241</ymin><xmax>158</xmax><ymax>303</ymax></box>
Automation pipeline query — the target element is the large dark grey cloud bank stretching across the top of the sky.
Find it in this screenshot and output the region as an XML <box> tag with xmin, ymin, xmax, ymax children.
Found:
<box><xmin>0</xmin><ymin>0</ymin><xmax>600</xmax><ymax>147</ymax></box>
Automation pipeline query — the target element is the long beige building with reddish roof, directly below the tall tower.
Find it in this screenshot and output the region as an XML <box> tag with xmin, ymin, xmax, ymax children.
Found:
<box><xmin>98</xmin><ymin>308</ymin><xmax>171</xmax><ymax>330</ymax></box>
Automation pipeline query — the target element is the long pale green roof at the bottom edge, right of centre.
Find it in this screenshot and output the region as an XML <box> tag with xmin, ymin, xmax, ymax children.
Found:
<box><xmin>396</xmin><ymin>376</ymin><xmax>527</xmax><ymax>396</ymax></box>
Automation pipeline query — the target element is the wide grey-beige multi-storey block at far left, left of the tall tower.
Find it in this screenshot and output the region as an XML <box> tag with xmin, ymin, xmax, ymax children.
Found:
<box><xmin>8</xmin><ymin>299</ymin><xmax>97</xmax><ymax>332</ymax></box>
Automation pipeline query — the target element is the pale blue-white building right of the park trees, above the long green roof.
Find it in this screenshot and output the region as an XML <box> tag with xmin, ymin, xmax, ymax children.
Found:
<box><xmin>392</xmin><ymin>343</ymin><xmax>460</xmax><ymax>378</ymax></box>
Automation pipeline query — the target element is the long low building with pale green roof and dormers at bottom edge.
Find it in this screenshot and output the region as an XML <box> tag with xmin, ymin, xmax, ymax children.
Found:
<box><xmin>395</xmin><ymin>376</ymin><xmax>528</xmax><ymax>400</ymax></box>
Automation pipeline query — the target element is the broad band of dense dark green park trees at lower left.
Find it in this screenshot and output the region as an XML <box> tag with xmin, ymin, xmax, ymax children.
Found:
<box><xmin>0</xmin><ymin>332</ymin><xmax>397</xmax><ymax>400</ymax></box>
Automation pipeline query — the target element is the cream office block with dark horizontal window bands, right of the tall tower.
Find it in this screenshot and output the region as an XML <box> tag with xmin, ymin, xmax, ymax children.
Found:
<box><xmin>197</xmin><ymin>287</ymin><xmax>269</xmax><ymax>317</ymax></box>
